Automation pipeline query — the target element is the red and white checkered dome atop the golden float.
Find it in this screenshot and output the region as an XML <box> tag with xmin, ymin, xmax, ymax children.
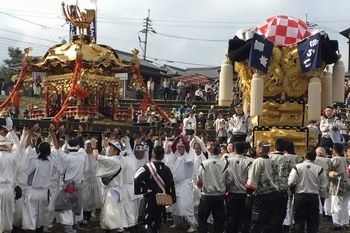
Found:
<box><xmin>254</xmin><ymin>15</ymin><xmax>311</xmax><ymax>45</ymax></box>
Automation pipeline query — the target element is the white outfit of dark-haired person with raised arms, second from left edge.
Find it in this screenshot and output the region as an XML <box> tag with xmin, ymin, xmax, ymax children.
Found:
<box><xmin>22</xmin><ymin>147</ymin><xmax>54</xmax><ymax>230</ymax></box>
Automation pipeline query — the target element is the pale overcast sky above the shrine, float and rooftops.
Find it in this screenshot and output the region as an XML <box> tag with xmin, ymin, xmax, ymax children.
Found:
<box><xmin>0</xmin><ymin>0</ymin><xmax>350</xmax><ymax>70</ymax></box>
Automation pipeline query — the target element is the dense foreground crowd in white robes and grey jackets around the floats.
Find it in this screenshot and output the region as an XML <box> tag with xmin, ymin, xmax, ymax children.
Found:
<box><xmin>0</xmin><ymin>98</ymin><xmax>350</xmax><ymax>233</ymax></box>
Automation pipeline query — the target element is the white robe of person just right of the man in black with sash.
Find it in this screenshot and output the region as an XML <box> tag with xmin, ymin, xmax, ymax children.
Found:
<box><xmin>167</xmin><ymin>151</ymin><xmax>194</xmax><ymax>216</ymax></box>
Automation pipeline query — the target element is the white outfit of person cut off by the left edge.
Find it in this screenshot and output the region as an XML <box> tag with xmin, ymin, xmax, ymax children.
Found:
<box><xmin>0</xmin><ymin>150</ymin><xmax>19</xmax><ymax>232</ymax></box>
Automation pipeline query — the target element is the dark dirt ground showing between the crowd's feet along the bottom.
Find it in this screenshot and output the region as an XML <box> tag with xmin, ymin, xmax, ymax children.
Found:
<box><xmin>52</xmin><ymin>215</ymin><xmax>350</xmax><ymax>233</ymax></box>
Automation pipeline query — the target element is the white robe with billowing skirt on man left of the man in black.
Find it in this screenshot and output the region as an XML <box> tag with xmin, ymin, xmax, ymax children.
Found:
<box><xmin>96</xmin><ymin>155</ymin><xmax>127</xmax><ymax>229</ymax></box>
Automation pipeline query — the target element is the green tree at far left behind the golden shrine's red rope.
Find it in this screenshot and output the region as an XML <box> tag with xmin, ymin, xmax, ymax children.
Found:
<box><xmin>0</xmin><ymin>46</ymin><xmax>24</xmax><ymax>83</ymax></box>
